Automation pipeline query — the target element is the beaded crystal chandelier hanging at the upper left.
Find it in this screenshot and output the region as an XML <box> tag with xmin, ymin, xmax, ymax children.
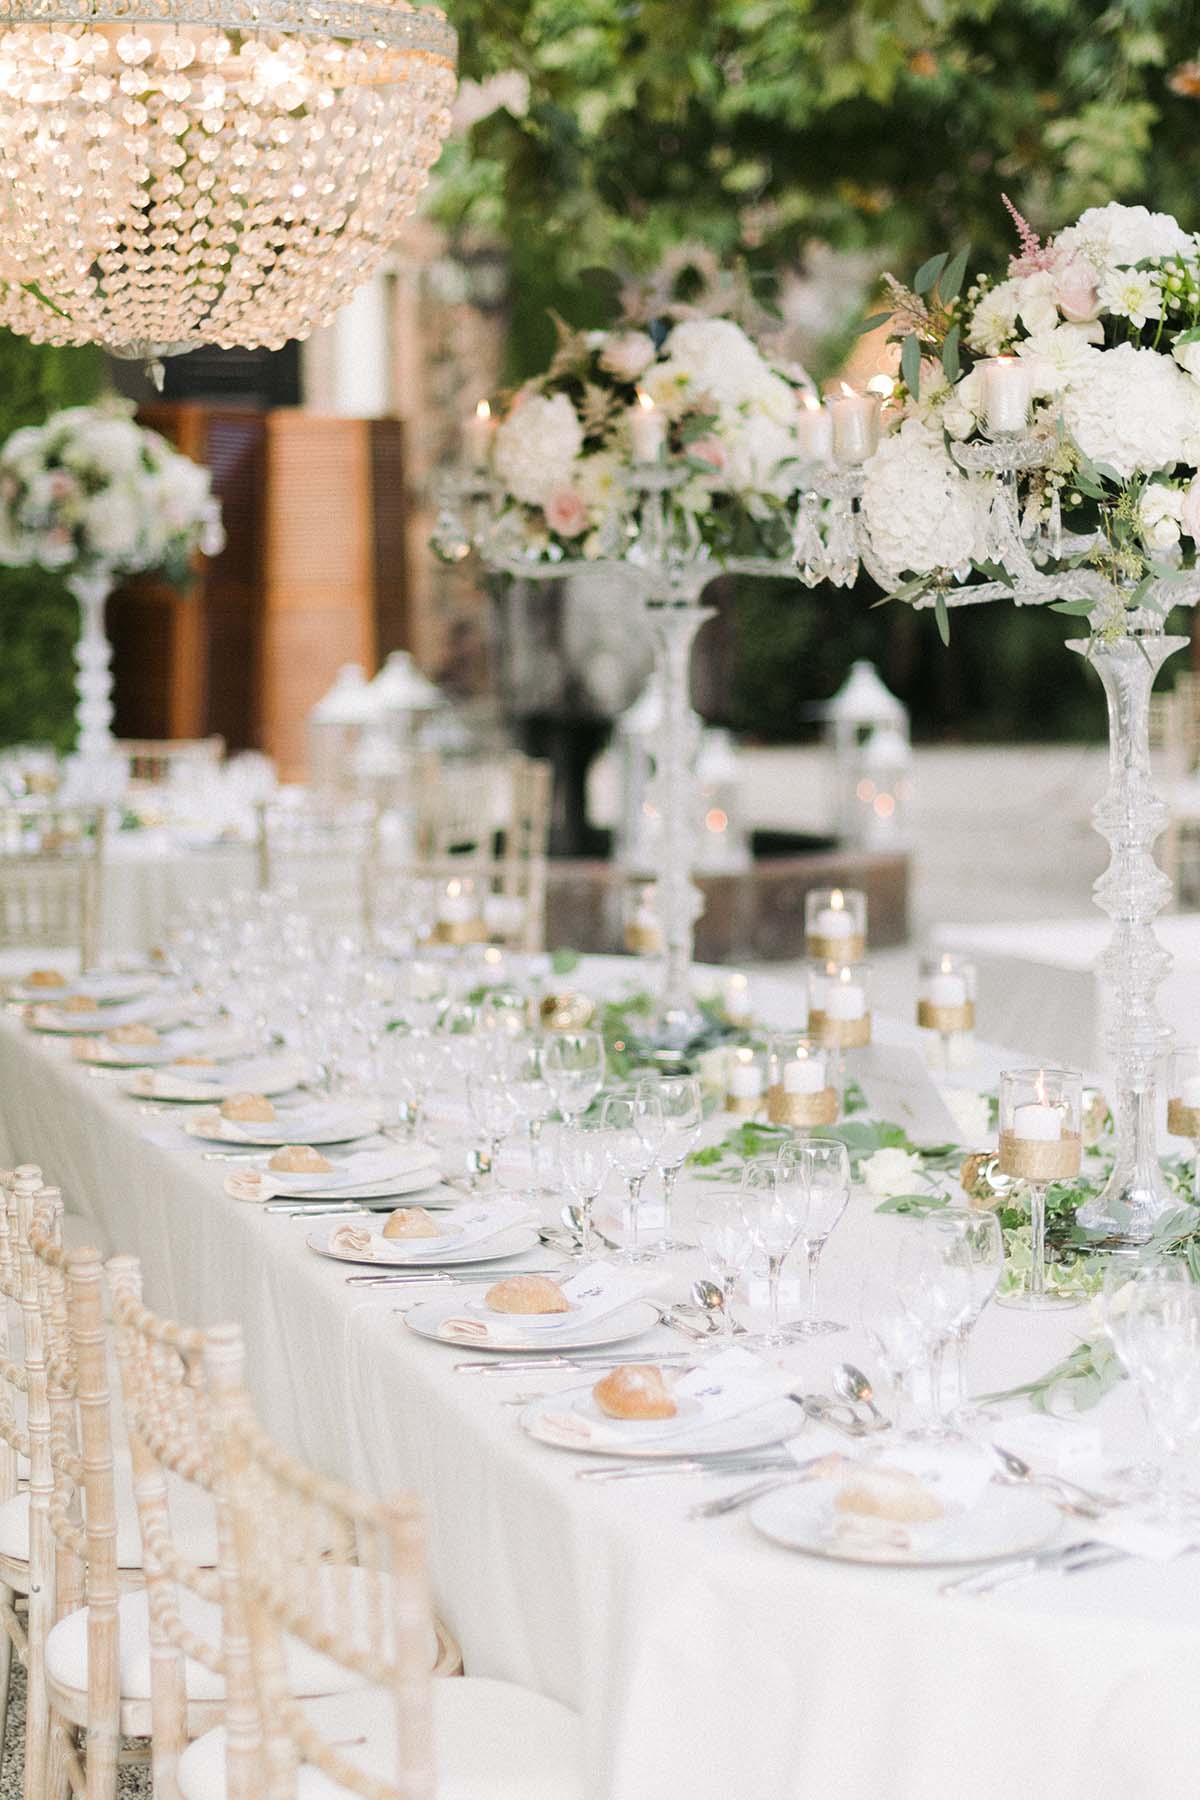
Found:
<box><xmin>0</xmin><ymin>0</ymin><xmax>455</xmax><ymax>364</ymax></box>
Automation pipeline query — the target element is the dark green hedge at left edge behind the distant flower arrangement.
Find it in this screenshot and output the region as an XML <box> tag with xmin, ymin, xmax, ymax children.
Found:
<box><xmin>0</xmin><ymin>331</ymin><xmax>101</xmax><ymax>749</ymax></box>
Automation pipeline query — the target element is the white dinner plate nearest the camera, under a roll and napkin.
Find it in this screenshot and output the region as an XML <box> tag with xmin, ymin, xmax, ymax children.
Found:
<box><xmin>750</xmin><ymin>1476</ymin><xmax>1063</xmax><ymax>1568</ymax></box>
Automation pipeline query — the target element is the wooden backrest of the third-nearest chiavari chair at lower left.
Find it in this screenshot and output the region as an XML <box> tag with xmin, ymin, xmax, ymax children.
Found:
<box><xmin>22</xmin><ymin>1188</ymin><xmax>121</xmax><ymax>1793</ymax></box>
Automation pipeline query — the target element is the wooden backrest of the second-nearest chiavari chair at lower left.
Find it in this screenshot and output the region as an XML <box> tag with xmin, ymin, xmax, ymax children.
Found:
<box><xmin>108</xmin><ymin>1256</ymin><xmax>255</xmax><ymax>1800</ymax></box>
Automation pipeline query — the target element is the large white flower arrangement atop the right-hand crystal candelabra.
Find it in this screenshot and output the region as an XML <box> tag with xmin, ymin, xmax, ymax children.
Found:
<box><xmin>862</xmin><ymin>200</ymin><xmax>1200</xmax><ymax>635</ymax></box>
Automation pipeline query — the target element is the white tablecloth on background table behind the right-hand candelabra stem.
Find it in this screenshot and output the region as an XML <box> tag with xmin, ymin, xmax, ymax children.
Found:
<box><xmin>934</xmin><ymin>913</ymin><xmax>1200</xmax><ymax>1069</ymax></box>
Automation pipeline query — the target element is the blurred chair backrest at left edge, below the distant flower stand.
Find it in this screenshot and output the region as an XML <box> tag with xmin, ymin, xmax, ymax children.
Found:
<box><xmin>0</xmin><ymin>806</ymin><xmax>104</xmax><ymax>968</ymax></box>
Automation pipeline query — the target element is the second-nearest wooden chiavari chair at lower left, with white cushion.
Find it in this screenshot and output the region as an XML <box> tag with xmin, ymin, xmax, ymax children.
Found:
<box><xmin>107</xmin><ymin>1256</ymin><xmax>461</xmax><ymax>1800</ymax></box>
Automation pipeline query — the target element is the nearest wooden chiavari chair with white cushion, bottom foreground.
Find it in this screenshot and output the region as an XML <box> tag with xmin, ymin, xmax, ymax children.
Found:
<box><xmin>180</xmin><ymin>1328</ymin><xmax>583</xmax><ymax>1800</ymax></box>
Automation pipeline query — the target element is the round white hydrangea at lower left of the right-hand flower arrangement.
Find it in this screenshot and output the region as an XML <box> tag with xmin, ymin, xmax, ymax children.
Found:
<box><xmin>862</xmin><ymin>419</ymin><xmax>988</xmax><ymax>576</ymax></box>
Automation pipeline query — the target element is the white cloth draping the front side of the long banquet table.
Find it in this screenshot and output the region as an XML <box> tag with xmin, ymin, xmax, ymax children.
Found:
<box><xmin>0</xmin><ymin>977</ymin><xmax>1200</xmax><ymax>1800</ymax></box>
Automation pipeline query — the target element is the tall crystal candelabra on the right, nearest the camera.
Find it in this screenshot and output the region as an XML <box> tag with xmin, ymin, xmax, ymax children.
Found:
<box><xmin>841</xmin><ymin>430</ymin><xmax>1200</xmax><ymax>1246</ymax></box>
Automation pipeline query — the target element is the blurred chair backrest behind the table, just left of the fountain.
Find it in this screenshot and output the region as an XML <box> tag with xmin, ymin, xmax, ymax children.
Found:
<box><xmin>406</xmin><ymin>754</ymin><xmax>551</xmax><ymax>950</ymax></box>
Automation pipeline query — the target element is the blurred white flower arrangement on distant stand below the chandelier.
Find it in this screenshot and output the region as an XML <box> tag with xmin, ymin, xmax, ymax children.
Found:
<box><xmin>0</xmin><ymin>400</ymin><xmax>225</xmax><ymax>583</ymax></box>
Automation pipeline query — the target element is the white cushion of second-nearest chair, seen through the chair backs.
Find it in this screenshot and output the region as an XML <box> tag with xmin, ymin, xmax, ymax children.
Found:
<box><xmin>45</xmin><ymin>1564</ymin><xmax>441</xmax><ymax>1699</ymax></box>
